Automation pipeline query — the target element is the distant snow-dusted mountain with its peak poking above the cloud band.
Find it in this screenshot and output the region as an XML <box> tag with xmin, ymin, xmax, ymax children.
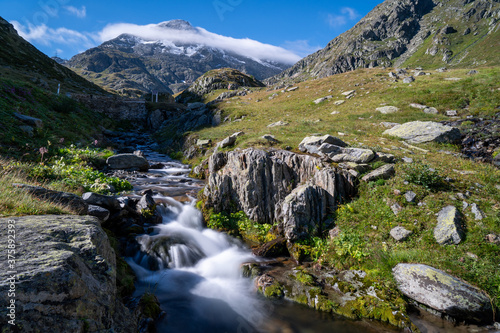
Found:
<box><xmin>64</xmin><ymin>20</ymin><xmax>289</xmax><ymax>94</ymax></box>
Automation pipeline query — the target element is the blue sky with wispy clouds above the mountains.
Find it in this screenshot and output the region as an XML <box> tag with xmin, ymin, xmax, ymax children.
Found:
<box><xmin>0</xmin><ymin>0</ymin><xmax>382</xmax><ymax>58</ymax></box>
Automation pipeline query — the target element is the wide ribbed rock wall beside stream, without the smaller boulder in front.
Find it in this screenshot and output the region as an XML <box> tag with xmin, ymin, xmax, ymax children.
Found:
<box><xmin>203</xmin><ymin>148</ymin><xmax>355</xmax><ymax>228</ymax></box>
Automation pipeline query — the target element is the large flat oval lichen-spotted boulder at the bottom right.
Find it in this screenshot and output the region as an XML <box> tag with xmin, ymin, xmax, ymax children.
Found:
<box><xmin>392</xmin><ymin>264</ymin><xmax>493</xmax><ymax>323</ymax></box>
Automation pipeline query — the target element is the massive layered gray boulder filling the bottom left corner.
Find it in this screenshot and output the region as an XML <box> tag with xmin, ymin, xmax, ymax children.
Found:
<box><xmin>0</xmin><ymin>215</ymin><xmax>137</xmax><ymax>332</ymax></box>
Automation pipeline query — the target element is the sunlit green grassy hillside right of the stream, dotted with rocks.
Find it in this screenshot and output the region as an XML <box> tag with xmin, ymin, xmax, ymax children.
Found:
<box><xmin>177</xmin><ymin>67</ymin><xmax>500</xmax><ymax>306</ymax></box>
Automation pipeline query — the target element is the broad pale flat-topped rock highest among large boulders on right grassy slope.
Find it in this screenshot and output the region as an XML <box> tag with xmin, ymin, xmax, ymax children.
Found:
<box><xmin>383</xmin><ymin>121</ymin><xmax>461</xmax><ymax>143</ymax></box>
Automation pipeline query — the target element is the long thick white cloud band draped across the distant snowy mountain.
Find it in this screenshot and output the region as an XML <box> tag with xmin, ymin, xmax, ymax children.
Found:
<box><xmin>99</xmin><ymin>23</ymin><xmax>301</xmax><ymax>64</ymax></box>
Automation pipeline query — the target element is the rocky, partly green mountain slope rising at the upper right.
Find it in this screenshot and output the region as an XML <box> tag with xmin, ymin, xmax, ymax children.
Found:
<box><xmin>268</xmin><ymin>0</ymin><xmax>500</xmax><ymax>84</ymax></box>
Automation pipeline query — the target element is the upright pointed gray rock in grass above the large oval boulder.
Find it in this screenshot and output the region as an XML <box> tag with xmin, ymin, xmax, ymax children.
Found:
<box><xmin>434</xmin><ymin>206</ymin><xmax>465</xmax><ymax>245</ymax></box>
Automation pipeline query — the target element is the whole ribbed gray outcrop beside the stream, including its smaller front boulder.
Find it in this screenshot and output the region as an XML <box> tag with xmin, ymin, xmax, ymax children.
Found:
<box><xmin>204</xmin><ymin>148</ymin><xmax>355</xmax><ymax>240</ymax></box>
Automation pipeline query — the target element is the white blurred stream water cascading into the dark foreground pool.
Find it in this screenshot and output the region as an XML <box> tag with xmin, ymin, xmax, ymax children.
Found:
<box><xmin>121</xmin><ymin>146</ymin><xmax>484</xmax><ymax>333</ymax></box>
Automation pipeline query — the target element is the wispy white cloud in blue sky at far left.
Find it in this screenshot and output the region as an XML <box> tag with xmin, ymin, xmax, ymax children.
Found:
<box><xmin>11</xmin><ymin>21</ymin><xmax>96</xmax><ymax>48</ymax></box>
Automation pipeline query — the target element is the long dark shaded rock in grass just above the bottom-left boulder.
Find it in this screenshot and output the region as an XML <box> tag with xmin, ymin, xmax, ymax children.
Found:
<box><xmin>12</xmin><ymin>184</ymin><xmax>88</xmax><ymax>215</ymax></box>
